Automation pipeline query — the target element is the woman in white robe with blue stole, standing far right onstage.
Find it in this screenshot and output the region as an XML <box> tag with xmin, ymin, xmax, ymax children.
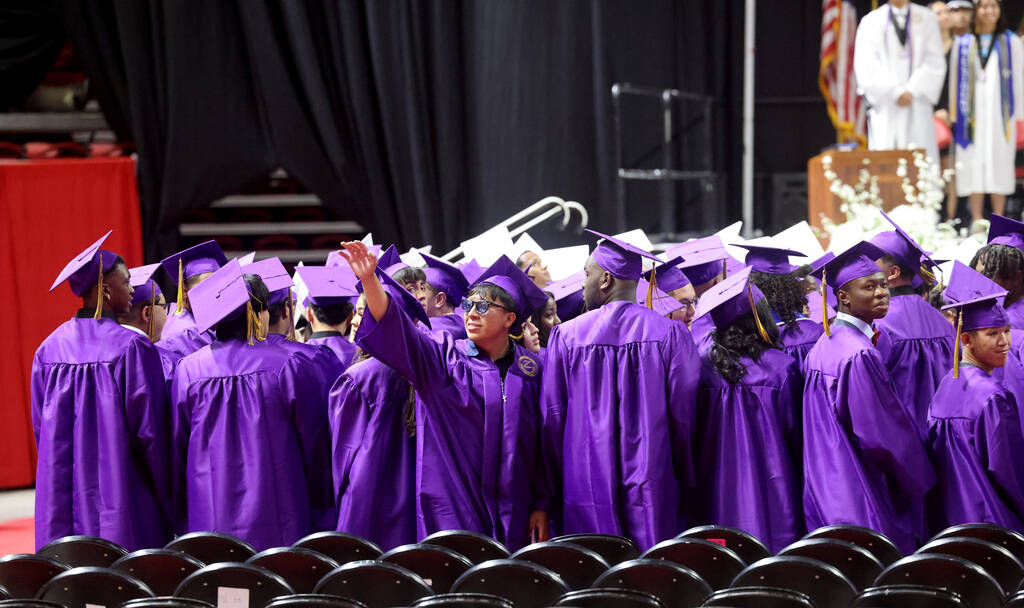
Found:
<box><xmin>949</xmin><ymin>0</ymin><xmax>1024</xmax><ymax>221</ymax></box>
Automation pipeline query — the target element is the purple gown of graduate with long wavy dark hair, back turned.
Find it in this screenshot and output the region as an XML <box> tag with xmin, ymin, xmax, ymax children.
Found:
<box><xmin>691</xmin><ymin>350</ymin><xmax>804</xmax><ymax>553</ymax></box>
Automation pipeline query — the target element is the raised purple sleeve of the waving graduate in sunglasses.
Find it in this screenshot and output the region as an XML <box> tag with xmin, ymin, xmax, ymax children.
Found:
<box><xmin>355</xmin><ymin>296</ymin><xmax>452</xmax><ymax>390</ymax></box>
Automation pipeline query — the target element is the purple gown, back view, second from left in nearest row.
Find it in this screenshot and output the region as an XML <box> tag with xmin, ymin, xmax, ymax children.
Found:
<box><xmin>172</xmin><ymin>340</ymin><xmax>333</xmax><ymax>551</ymax></box>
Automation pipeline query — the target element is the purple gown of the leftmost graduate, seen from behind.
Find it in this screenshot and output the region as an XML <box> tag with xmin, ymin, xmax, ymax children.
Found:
<box><xmin>32</xmin><ymin>313</ymin><xmax>183</xmax><ymax>551</ymax></box>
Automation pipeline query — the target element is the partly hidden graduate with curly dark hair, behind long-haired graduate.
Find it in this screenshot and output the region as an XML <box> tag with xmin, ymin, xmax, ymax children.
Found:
<box><xmin>736</xmin><ymin>245</ymin><xmax>823</xmax><ymax>364</ymax></box>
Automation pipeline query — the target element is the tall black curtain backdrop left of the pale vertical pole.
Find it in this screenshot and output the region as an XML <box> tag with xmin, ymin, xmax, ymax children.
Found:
<box><xmin>58</xmin><ymin>0</ymin><xmax>742</xmax><ymax>259</ymax></box>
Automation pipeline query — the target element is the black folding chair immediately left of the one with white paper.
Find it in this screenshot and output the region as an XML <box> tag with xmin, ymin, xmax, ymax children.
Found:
<box><xmin>38</xmin><ymin>566</ymin><xmax>154</xmax><ymax>608</ymax></box>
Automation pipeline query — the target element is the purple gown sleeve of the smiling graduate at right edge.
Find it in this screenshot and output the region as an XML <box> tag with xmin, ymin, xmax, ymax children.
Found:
<box><xmin>974</xmin><ymin>394</ymin><xmax>1024</xmax><ymax>517</ymax></box>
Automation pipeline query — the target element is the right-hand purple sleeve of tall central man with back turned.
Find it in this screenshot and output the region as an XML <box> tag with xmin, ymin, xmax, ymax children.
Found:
<box><xmin>663</xmin><ymin>323</ymin><xmax>700</xmax><ymax>487</ymax></box>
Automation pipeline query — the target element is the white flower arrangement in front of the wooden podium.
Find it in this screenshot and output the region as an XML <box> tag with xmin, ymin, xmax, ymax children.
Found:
<box><xmin>821</xmin><ymin>151</ymin><xmax>958</xmax><ymax>252</ymax></box>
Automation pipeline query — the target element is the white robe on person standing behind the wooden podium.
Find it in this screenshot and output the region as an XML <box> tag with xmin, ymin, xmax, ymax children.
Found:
<box><xmin>853</xmin><ymin>3</ymin><xmax>946</xmax><ymax>162</ymax></box>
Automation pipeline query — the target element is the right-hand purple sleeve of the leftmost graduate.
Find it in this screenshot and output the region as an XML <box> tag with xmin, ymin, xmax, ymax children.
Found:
<box><xmin>118</xmin><ymin>338</ymin><xmax>185</xmax><ymax>523</ymax></box>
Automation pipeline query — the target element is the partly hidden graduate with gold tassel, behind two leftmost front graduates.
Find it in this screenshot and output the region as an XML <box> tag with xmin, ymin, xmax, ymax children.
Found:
<box><xmin>160</xmin><ymin>241</ymin><xmax>227</xmax><ymax>357</ymax></box>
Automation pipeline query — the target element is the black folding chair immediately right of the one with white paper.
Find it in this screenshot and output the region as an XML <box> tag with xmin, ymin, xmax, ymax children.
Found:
<box><xmin>313</xmin><ymin>561</ymin><xmax>434</xmax><ymax>608</ymax></box>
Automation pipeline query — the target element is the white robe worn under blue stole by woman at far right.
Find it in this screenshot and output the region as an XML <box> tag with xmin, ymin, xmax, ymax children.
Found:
<box><xmin>949</xmin><ymin>34</ymin><xmax>1024</xmax><ymax>197</ymax></box>
